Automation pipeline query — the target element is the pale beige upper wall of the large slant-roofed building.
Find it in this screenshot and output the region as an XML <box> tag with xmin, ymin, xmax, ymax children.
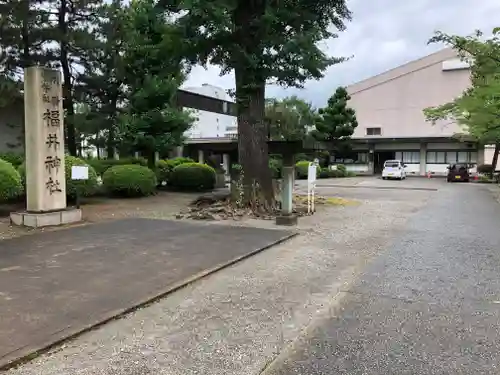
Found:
<box><xmin>347</xmin><ymin>49</ymin><xmax>470</xmax><ymax>138</ymax></box>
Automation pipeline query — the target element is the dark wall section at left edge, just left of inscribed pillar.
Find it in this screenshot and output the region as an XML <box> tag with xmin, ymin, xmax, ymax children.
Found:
<box><xmin>0</xmin><ymin>102</ymin><xmax>24</xmax><ymax>153</ymax></box>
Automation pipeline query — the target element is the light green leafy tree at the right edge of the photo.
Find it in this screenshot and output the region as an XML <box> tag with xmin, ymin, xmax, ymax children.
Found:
<box><xmin>424</xmin><ymin>28</ymin><xmax>500</xmax><ymax>168</ymax></box>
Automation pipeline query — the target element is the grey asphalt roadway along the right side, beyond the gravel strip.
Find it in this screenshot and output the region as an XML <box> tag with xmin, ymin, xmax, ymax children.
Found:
<box><xmin>264</xmin><ymin>184</ymin><xmax>500</xmax><ymax>375</ymax></box>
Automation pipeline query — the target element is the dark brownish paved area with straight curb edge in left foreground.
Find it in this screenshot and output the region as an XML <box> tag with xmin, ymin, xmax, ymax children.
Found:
<box><xmin>0</xmin><ymin>219</ymin><xmax>291</xmax><ymax>366</ymax></box>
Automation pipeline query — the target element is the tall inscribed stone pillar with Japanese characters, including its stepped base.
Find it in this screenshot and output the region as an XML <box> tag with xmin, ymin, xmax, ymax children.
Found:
<box><xmin>11</xmin><ymin>67</ymin><xmax>81</xmax><ymax>227</ymax></box>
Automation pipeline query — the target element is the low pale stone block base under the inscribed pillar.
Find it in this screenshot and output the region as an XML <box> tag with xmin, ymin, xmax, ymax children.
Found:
<box><xmin>10</xmin><ymin>208</ymin><xmax>82</xmax><ymax>228</ymax></box>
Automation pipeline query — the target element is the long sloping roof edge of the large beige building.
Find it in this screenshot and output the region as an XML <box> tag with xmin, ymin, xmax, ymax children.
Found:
<box><xmin>347</xmin><ymin>48</ymin><xmax>458</xmax><ymax>95</ymax></box>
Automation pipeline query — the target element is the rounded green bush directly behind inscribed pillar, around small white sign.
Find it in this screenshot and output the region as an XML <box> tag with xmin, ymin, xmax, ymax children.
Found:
<box><xmin>18</xmin><ymin>155</ymin><xmax>99</xmax><ymax>199</ymax></box>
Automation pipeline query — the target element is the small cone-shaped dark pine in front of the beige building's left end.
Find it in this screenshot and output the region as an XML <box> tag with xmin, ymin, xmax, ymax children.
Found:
<box><xmin>311</xmin><ymin>87</ymin><xmax>358</xmax><ymax>150</ymax></box>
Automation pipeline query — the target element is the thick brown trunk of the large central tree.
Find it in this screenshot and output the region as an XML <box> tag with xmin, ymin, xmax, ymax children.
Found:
<box><xmin>235</xmin><ymin>69</ymin><xmax>275</xmax><ymax>212</ymax></box>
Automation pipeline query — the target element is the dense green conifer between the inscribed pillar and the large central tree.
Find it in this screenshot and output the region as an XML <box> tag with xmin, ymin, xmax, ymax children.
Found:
<box><xmin>122</xmin><ymin>0</ymin><xmax>194</xmax><ymax>169</ymax></box>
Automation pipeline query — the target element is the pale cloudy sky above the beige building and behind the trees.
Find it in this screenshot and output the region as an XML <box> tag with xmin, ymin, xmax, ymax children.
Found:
<box><xmin>186</xmin><ymin>0</ymin><xmax>500</xmax><ymax>106</ymax></box>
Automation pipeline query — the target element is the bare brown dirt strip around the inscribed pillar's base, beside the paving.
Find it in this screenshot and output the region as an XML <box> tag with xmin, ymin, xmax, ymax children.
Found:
<box><xmin>0</xmin><ymin>192</ymin><xmax>199</xmax><ymax>240</ymax></box>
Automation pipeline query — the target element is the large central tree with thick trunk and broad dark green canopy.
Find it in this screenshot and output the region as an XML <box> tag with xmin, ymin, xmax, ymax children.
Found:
<box><xmin>172</xmin><ymin>0</ymin><xmax>351</xmax><ymax>210</ymax></box>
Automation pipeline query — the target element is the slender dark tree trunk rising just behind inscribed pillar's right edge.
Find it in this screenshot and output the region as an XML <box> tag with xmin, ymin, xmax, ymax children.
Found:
<box><xmin>58</xmin><ymin>0</ymin><xmax>77</xmax><ymax>156</ymax></box>
